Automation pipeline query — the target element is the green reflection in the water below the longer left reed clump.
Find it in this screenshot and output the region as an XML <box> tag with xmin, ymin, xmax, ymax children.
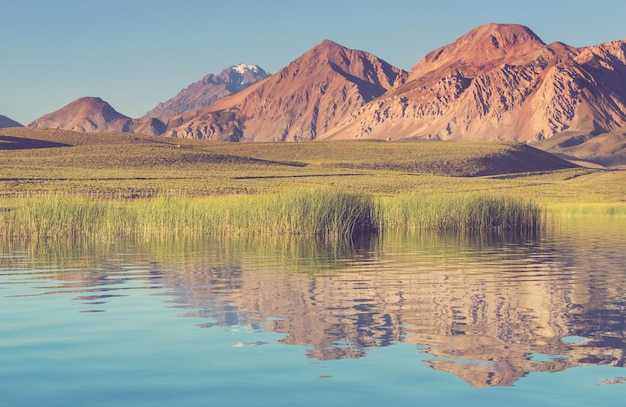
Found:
<box><xmin>1</xmin><ymin>234</ymin><xmax>379</xmax><ymax>274</ymax></box>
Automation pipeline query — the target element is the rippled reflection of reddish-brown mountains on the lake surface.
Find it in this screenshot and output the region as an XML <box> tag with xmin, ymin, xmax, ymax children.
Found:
<box><xmin>15</xmin><ymin>221</ymin><xmax>626</xmax><ymax>386</ymax></box>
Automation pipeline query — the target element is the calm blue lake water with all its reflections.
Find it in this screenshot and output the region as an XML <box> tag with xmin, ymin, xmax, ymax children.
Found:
<box><xmin>0</xmin><ymin>219</ymin><xmax>626</xmax><ymax>407</ymax></box>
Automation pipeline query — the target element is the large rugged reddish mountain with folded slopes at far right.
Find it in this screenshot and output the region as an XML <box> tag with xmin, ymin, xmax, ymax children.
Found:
<box><xmin>325</xmin><ymin>24</ymin><xmax>626</xmax><ymax>147</ymax></box>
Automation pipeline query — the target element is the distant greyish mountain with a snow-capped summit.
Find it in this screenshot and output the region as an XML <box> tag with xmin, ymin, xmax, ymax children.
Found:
<box><xmin>144</xmin><ymin>64</ymin><xmax>270</xmax><ymax>118</ymax></box>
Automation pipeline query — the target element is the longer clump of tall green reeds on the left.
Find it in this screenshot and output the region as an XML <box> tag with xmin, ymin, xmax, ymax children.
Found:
<box><xmin>0</xmin><ymin>188</ymin><xmax>377</xmax><ymax>239</ymax></box>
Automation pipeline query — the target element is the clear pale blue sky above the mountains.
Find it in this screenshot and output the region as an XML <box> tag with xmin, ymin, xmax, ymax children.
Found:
<box><xmin>0</xmin><ymin>0</ymin><xmax>626</xmax><ymax>125</ymax></box>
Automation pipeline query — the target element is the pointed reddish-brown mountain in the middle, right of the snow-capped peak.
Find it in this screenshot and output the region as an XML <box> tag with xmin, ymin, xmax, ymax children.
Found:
<box><xmin>161</xmin><ymin>40</ymin><xmax>407</xmax><ymax>141</ymax></box>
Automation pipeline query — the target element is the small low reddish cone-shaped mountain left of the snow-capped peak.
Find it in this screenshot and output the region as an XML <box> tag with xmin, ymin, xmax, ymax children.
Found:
<box><xmin>29</xmin><ymin>97</ymin><xmax>133</xmax><ymax>132</ymax></box>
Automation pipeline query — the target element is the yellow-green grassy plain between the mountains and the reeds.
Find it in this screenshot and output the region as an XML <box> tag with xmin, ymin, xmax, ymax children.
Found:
<box><xmin>0</xmin><ymin>128</ymin><xmax>626</xmax><ymax>239</ymax></box>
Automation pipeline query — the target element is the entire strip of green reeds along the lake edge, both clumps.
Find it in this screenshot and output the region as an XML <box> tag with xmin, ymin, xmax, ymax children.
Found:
<box><xmin>0</xmin><ymin>188</ymin><xmax>542</xmax><ymax>240</ymax></box>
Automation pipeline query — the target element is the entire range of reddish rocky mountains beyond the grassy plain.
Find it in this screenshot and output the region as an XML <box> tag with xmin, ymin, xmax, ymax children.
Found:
<box><xmin>22</xmin><ymin>24</ymin><xmax>626</xmax><ymax>165</ymax></box>
